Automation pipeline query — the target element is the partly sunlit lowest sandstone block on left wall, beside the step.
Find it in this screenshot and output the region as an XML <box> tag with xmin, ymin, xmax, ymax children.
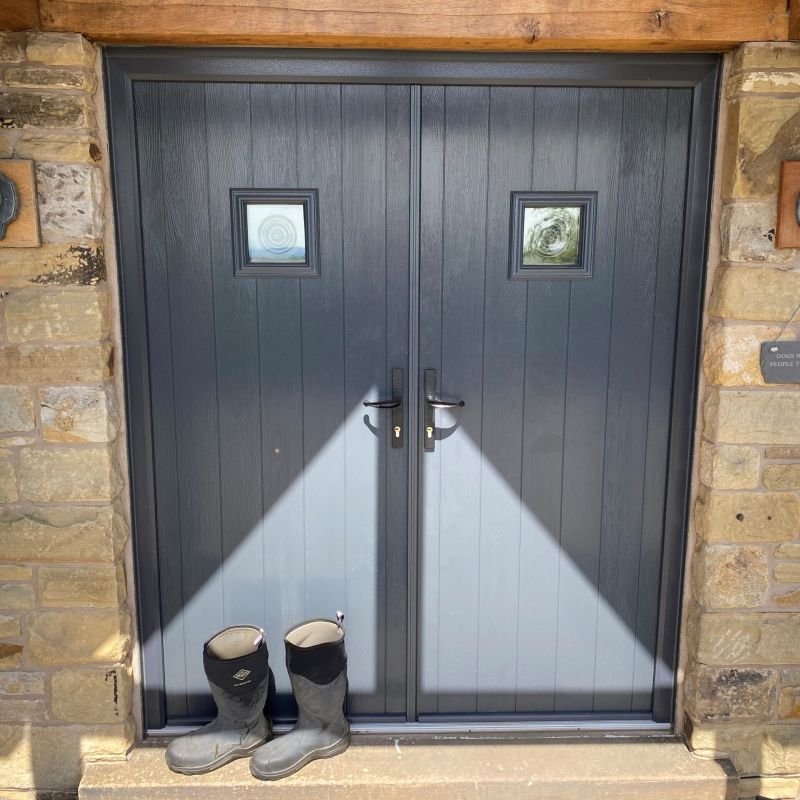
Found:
<box><xmin>0</xmin><ymin>720</ymin><xmax>134</xmax><ymax>792</ymax></box>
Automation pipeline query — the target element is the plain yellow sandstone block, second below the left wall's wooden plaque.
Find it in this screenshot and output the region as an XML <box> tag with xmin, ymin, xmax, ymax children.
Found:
<box><xmin>4</xmin><ymin>287</ymin><xmax>109</xmax><ymax>342</ymax></box>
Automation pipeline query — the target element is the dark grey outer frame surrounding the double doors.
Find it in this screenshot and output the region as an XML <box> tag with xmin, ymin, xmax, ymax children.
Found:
<box><xmin>104</xmin><ymin>46</ymin><xmax>720</xmax><ymax>732</ymax></box>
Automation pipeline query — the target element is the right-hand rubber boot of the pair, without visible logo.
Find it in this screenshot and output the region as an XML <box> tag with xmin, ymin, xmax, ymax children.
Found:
<box><xmin>250</xmin><ymin>619</ymin><xmax>350</xmax><ymax>781</ymax></box>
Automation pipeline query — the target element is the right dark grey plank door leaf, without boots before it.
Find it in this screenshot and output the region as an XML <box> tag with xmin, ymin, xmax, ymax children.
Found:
<box><xmin>419</xmin><ymin>87</ymin><xmax>691</xmax><ymax>718</ymax></box>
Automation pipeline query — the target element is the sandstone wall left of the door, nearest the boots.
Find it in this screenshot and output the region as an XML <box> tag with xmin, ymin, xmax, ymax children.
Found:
<box><xmin>0</xmin><ymin>33</ymin><xmax>133</xmax><ymax>798</ymax></box>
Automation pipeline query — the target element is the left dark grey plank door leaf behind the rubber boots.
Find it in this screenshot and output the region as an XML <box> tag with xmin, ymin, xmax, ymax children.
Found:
<box><xmin>134</xmin><ymin>83</ymin><xmax>410</xmax><ymax>723</ymax></box>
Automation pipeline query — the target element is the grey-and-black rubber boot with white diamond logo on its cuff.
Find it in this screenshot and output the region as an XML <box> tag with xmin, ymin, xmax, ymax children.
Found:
<box><xmin>166</xmin><ymin>625</ymin><xmax>273</xmax><ymax>775</ymax></box>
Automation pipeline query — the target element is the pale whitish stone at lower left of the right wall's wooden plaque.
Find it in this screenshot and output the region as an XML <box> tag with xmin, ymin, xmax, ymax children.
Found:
<box><xmin>720</xmin><ymin>202</ymin><xmax>794</xmax><ymax>264</ymax></box>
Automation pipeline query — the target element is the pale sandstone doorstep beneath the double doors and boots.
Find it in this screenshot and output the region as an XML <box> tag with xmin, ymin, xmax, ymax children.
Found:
<box><xmin>79</xmin><ymin>737</ymin><xmax>738</xmax><ymax>800</ymax></box>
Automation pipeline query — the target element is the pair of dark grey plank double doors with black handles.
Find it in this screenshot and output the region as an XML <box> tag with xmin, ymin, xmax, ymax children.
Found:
<box><xmin>128</xmin><ymin>72</ymin><xmax>692</xmax><ymax>724</ymax></box>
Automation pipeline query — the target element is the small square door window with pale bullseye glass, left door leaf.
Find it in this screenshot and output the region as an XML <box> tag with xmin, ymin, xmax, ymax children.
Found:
<box><xmin>231</xmin><ymin>189</ymin><xmax>319</xmax><ymax>278</ymax></box>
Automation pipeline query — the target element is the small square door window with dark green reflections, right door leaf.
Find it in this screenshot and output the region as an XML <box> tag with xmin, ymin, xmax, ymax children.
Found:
<box><xmin>508</xmin><ymin>192</ymin><xmax>597</xmax><ymax>280</ymax></box>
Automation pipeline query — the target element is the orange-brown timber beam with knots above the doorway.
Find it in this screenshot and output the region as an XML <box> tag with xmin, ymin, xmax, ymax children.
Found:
<box><xmin>39</xmin><ymin>0</ymin><xmax>789</xmax><ymax>52</ymax></box>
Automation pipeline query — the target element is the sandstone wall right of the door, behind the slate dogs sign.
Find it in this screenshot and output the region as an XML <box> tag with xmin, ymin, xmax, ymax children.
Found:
<box><xmin>685</xmin><ymin>44</ymin><xmax>800</xmax><ymax>798</ymax></box>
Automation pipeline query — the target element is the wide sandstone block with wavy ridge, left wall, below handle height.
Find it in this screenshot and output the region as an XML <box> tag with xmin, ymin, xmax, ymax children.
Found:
<box><xmin>0</xmin><ymin>506</ymin><xmax>127</xmax><ymax>563</ymax></box>
